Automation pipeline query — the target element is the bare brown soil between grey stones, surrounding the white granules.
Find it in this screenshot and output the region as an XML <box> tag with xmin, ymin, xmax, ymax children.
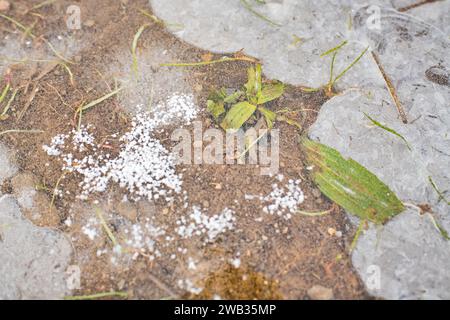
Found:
<box><xmin>0</xmin><ymin>0</ymin><xmax>367</xmax><ymax>299</ymax></box>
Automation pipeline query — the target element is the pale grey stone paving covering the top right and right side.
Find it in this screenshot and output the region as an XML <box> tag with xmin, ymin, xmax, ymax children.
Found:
<box><xmin>150</xmin><ymin>0</ymin><xmax>450</xmax><ymax>299</ymax></box>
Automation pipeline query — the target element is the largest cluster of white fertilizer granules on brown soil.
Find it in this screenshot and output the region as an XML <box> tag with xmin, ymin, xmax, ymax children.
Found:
<box><xmin>43</xmin><ymin>93</ymin><xmax>198</xmax><ymax>202</ymax></box>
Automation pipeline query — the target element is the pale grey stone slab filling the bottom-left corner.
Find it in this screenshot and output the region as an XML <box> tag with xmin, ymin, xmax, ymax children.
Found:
<box><xmin>0</xmin><ymin>196</ymin><xmax>72</xmax><ymax>299</ymax></box>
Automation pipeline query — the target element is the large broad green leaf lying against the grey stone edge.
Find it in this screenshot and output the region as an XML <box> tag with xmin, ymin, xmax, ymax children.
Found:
<box><xmin>302</xmin><ymin>139</ymin><xmax>404</xmax><ymax>224</ymax></box>
